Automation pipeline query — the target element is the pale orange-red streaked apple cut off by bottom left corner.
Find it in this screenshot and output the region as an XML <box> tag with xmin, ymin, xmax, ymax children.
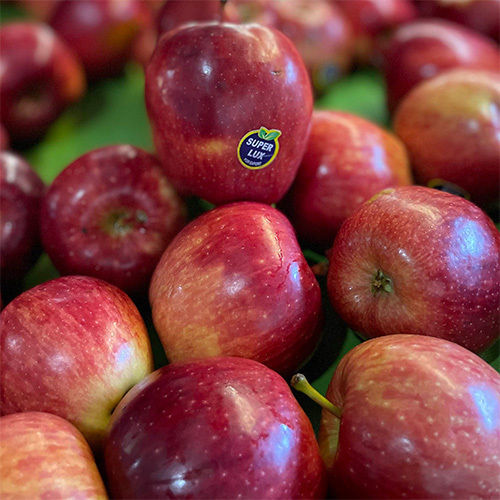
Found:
<box><xmin>0</xmin><ymin>412</ymin><xmax>108</xmax><ymax>500</ymax></box>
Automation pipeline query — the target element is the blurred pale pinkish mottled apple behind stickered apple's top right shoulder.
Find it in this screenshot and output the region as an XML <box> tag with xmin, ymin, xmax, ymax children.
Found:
<box><xmin>229</xmin><ymin>0</ymin><xmax>354</xmax><ymax>92</ymax></box>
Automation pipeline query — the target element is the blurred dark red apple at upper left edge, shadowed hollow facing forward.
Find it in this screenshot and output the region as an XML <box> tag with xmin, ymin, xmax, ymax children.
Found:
<box><xmin>0</xmin><ymin>22</ymin><xmax>85</xmax><ymax>146</ymax></box>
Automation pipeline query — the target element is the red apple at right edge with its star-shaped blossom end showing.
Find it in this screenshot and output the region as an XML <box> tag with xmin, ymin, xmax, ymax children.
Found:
<box><xmin>328</xmin><ymin>186</ymin><xmax>500</xmax><ymax>352</ymax></box>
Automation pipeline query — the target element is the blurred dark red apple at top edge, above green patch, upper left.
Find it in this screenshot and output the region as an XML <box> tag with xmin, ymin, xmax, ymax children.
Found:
<box><xmin>50</xmin><ymin>0</ymin><xmax>151</xmax><ymax>80</ymax></box>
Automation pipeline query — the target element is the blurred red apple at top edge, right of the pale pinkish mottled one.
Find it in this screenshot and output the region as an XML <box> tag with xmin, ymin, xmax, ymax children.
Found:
<box><xmin>335</xmin><ymin>0</ymin><xmax>417</xmax><ymax>63</ymax></box>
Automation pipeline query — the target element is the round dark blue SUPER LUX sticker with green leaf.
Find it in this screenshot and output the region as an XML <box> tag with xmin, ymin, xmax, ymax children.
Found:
<box><xmin>238</xmin><ymin>127</ymin><xmax>281</xmax><ymax>170</ymax></box>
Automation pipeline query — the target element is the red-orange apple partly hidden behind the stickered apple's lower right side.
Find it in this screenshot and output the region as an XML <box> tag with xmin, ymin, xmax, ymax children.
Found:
<box><xmin>284</xmin><ymin>111</ymin><xmax>412</xmax><ymax>249</ymax></box>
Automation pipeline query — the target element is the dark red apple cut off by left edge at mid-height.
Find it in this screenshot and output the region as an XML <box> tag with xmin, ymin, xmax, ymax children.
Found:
<box><xmin>0</xmin><ymin>151</ymin><xmax>45</xmax><ymax>289</ymax></box>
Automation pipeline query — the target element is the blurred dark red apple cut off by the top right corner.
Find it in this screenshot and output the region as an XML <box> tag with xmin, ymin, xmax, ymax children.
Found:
<box><xmin>415</xmin><ymin>0</ymin><xmax>500</xmax><ymax>41</ymax></box>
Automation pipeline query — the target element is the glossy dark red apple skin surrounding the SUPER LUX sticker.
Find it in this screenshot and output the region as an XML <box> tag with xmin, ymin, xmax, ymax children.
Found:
<box><xmin>145</xmin><ymin>23</ymin><xmax>312</xmax><ymax>204</ymax></box>
